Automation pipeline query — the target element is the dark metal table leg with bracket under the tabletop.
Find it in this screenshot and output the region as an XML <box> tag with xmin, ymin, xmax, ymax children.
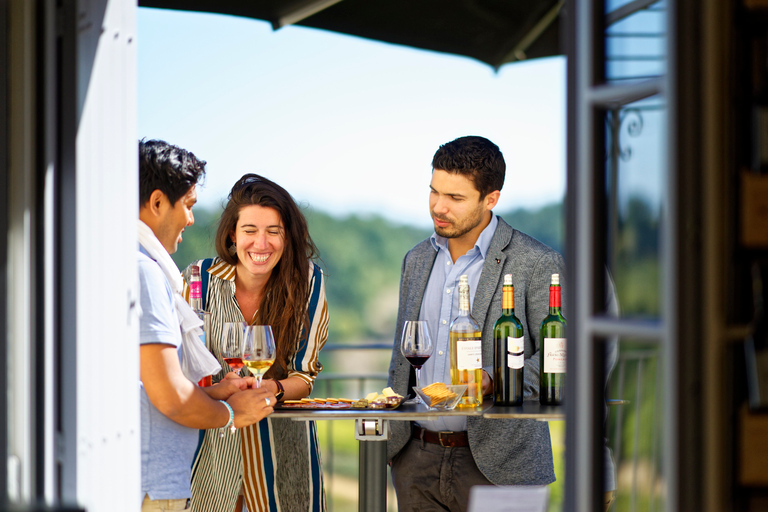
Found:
<box><xmin>355</xmin><ymin>419</ymin><xmax>389</xmax><ymax>512</ymax></box>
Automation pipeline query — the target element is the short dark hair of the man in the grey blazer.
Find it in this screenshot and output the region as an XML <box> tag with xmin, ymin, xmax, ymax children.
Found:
<box><xmin>432</xmin><ymin>135</ymin><xmax>507</xmax><ymax>198</ymax></box>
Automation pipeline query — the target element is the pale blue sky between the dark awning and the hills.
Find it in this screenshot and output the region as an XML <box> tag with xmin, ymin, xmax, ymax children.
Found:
<box><xmin>138</xmin><ymin>8</ymin><xmax>565</xmax><ymax>226</ymax></box>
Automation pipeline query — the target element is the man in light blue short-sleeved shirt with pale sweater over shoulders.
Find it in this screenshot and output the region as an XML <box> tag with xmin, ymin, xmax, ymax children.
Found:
<box><xmin>138</xmin><ymin>140</ymin><xmax>275</xmax><ymax>512</ymax></box>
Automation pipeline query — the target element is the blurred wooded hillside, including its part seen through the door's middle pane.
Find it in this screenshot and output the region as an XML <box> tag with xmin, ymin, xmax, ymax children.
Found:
<box><xmin>174</xmin><ymin>199</ymin><xmax>659</xmax><ymax>342</ymax></box>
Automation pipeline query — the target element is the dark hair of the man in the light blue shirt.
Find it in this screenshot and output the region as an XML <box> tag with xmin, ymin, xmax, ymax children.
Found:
<box><xmin>139</xmin><ymin>140</ymin><xmax>206</xmax><ymax>207</ymax></box>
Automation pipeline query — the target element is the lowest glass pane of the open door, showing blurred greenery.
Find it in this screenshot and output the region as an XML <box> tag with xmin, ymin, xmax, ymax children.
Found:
<box><xmin>605</xmin><ymin>339</ymin><xmax>668</xmax><ymax>512</ymax></box>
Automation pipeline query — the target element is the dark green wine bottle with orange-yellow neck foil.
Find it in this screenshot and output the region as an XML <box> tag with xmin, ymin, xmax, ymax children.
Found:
<box><xmin>493</xmin><ymin>274</ymin><xmax>525</xmax><ymax>405</ymax></box>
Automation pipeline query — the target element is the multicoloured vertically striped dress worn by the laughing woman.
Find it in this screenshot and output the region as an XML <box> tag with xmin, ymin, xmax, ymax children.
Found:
<box><xmin>183</xmin><ymin>258</ymin><xmax>328</xmax><ymax>512</ymax></box>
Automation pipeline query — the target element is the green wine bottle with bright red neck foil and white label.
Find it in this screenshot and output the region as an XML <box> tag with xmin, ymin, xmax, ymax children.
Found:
<box><xmin>539</xmin><ymin>274</ymin><xmax>566</xmax><ymax>405</ymax></box>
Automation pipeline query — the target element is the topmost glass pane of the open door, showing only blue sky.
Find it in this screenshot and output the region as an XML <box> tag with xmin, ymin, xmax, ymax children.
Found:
<box><xmin>605</xmin><ymin>0</ymin><xmax>667</xmax><ymax>83</ymax></box>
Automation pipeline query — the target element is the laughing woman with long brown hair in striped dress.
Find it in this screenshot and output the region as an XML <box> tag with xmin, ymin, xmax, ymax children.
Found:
<box><xmin>185</xmin><ymin>174</ymin><xmax>328</xmax><ymax>511</ymax></box>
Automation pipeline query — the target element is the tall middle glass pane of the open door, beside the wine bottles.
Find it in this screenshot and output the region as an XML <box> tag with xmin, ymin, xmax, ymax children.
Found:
<box><xmin>605</xmin><ymin>97</ymin><xmax>666</xmax><ymax>319</ymax></box>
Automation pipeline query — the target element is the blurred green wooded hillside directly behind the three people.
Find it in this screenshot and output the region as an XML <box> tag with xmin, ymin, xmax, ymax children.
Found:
<box><xmin>173</xmin><ymin>203</ymin><xmax>563</xmax><ymax>343</ymax></box>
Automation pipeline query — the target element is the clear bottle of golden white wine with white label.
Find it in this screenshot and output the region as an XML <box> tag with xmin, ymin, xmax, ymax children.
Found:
<box><xmin>450</xmin><ymin>275</ymin><xmax>483</xmax><ymax>407</ymax></box>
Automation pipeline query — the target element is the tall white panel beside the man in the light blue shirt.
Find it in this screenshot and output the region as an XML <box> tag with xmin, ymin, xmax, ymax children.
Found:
<box><xmin>76</xmin><ymin>0</ymin><xmax>140</xmax><ymax>512</ymax></box>
